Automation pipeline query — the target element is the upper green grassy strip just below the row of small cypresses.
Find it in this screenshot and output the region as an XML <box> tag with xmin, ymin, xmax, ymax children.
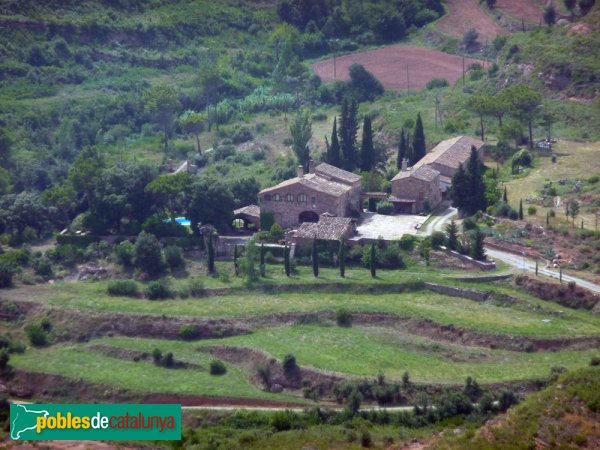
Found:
<box><xmin>9</xmin><ymin>268</ymin><xmax>600</xmax><ymax>337</ymax></box>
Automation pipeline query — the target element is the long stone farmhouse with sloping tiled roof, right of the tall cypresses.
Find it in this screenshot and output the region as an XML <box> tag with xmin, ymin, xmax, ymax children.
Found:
<box><xmin>389</xmin><ymin>136</ymin><xmax>485</xmax><ymax>214</ymax></box>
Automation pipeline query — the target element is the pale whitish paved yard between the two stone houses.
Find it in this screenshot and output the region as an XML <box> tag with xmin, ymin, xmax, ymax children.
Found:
<box><xmin>353</xmin><ymin>213</ymin><xmax>427</xmax><ymax>240</ymax></box>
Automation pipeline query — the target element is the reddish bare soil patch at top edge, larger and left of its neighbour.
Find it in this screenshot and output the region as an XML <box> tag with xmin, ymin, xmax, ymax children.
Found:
<box><xmin>437</xmin><ymin>0</ymin><xmax>506</xmax><ymax>43</ymax></box>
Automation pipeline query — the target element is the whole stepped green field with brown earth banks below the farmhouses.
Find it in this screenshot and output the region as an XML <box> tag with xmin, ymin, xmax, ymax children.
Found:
<box><xmin>2</xmin><ymin>269</ymin><xmax>600</xmax><ymax>404</ymax></box>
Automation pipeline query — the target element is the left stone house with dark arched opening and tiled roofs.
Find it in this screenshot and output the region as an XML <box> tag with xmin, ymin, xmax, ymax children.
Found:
<box><xmin>259</xmin><ymin>161</ymin><xmax>362</xmax><ymax>228</ymax></box>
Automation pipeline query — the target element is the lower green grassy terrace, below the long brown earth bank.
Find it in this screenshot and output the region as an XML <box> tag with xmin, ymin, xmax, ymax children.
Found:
<box><xmin>11</xmin><ymin>334</ymin><xmax>599</xmax><ymax>386</ymax></box>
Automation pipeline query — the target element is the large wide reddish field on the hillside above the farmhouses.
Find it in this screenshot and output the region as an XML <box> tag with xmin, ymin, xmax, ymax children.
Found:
<box><xmin>313</xmin><ymin>46</ymin><xmax>486</xmax><ymax>89</ymax></box>
